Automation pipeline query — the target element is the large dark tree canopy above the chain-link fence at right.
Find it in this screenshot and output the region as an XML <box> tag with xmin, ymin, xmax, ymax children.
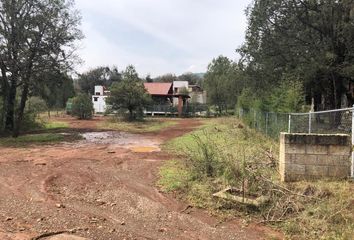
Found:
<box><xmin>238</xmin><ymin>0</ymin><xmax>354</xmax><ymax>111</ymax></box>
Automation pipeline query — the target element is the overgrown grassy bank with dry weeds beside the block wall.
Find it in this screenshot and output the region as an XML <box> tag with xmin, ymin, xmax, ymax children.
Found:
<box><xmin>158</xmin><ymin>118</ymin><xmax>354</xmax><ymax>239</ymax></box>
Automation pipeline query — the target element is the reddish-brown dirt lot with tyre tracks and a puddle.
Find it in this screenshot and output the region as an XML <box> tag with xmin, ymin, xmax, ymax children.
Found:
<box><xmin>0</xmin><ymin>119</ymin><xmax>280</xmax><ymax>240</ymax></box>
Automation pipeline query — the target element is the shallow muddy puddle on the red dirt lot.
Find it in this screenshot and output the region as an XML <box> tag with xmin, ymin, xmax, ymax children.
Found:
<box><xmin>82</xmin><ymin>131</ymin><xmax>160</xmax><ymax>153</ymax></box>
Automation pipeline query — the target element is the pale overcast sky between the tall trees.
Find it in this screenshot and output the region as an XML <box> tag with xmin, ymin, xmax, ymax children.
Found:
<box><xmin>76</xmin><ymin>0</ymin><xmax>251</xmax><ymax>76</ymax></box>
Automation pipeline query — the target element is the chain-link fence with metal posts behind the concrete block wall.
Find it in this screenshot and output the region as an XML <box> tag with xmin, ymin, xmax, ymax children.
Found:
<box><xmin>236</xmin><ymin>108</ymin><xmax>354</xmax><ymax>139</ymax></box>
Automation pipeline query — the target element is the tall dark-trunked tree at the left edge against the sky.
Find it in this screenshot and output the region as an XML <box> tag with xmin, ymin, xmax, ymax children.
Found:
<box><xmin>0</xmin><ymin>0</ymin><xmax>82</xmax><ymax>137</ymax></box>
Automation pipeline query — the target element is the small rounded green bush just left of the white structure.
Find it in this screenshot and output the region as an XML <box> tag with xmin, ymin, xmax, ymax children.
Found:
<box><xmin>71</xmin><ymin>94</ymin><xmax>93</xmax><ymax>119</ymax></box>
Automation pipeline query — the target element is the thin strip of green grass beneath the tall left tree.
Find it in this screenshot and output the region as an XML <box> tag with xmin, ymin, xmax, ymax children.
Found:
<box><xmin>0</xmin><ymin>133</ymin><xmax>65</xmax><ymax>146</ymax></box>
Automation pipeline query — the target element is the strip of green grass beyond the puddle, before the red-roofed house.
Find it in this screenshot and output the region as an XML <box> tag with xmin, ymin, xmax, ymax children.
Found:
<box><xmin>98</xmin><ymin>118</ymin><xmax>177</xmax><ymax>133</ymax></box>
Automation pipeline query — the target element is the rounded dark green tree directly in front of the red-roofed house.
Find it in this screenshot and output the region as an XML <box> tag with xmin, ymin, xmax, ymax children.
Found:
<box><xmin>106</xmin><ymin>66</ymin><xmax>151</xmax><ymax>121</ymax></box>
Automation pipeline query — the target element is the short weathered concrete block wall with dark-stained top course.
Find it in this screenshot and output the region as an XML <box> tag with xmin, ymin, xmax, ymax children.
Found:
<box><xmin>279</xmin><ymin>133</ymin><xmax>352</xmax><ymax>182</ymax></box>
